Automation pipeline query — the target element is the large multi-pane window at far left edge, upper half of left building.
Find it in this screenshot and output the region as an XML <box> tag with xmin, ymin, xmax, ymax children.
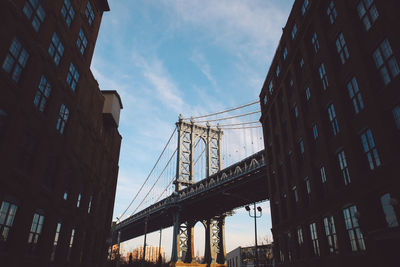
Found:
<box><xmin>3</xmin><ymin>37</ymin><xmax>29</xmax><ymax>82</ymax></box>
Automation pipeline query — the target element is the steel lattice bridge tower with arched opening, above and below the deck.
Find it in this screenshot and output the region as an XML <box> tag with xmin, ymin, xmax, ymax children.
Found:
<box><xmin>171</xmin><ymin>115</ymin><xmax>225</xmax><ymax>265</ymax></box>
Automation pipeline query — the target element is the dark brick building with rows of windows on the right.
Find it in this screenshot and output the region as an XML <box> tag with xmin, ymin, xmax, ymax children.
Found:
<box><xmin>260</xmin><ymin>0</ymin><xmax>400</xmax><ymax>266</ymax></box>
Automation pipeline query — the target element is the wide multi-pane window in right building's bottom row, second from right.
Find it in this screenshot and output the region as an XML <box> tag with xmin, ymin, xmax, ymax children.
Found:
<box><xmin>343</xmin><ymin>205</ymin><xmax>365</xmax><ymax>251</ymax></box>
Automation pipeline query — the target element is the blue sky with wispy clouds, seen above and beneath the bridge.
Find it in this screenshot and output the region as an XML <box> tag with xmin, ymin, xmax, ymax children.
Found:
<box><xmin>91</xmin><ymin>0</ymin><xmax>293</xmax><ymax>262</ymax></box>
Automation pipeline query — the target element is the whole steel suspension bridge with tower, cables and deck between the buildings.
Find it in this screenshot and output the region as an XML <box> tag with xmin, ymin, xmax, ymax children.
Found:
<box><xmin>113</xmin><ymin>101</ymin><xmax>268</xmax><ymax>266</ymax></box>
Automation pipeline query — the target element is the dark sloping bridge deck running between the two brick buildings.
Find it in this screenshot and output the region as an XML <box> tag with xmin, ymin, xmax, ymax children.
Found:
<box><xmin>113</xmin><ymin>150</ymin><xmax>268</xmax><ymax>243</ymax></box>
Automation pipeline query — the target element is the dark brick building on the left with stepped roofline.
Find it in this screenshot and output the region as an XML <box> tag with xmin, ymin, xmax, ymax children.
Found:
<box><xmin>0</xmin><ymin>0</ymin><xmax>122</xmax><ymax>266</ymax></box>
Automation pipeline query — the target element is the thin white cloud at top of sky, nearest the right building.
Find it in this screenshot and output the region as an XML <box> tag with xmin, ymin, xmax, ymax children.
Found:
<box><xmin>163</xmin><ymin>0</ymin><xmax>287</xmax><ymax>61</ymax></box>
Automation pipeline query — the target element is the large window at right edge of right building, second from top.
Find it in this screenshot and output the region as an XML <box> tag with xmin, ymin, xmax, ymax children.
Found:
<box><xmin>373</xmin><ymin>39</ymin><xmax>400</xmax><ymax>85</ymax></box>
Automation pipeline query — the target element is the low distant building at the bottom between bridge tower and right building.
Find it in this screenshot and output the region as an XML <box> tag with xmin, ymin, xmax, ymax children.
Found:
<box><xmin>226</xmin><ymin>244</ymin><xmax>272</xmax><ymax>267</ymax></box>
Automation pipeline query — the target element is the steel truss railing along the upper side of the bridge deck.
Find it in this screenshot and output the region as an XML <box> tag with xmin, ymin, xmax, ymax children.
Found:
<box><xmin>116</xmin><ymin>150</ymin><xmax>265</xmax><ymax>230</ymax></box>
